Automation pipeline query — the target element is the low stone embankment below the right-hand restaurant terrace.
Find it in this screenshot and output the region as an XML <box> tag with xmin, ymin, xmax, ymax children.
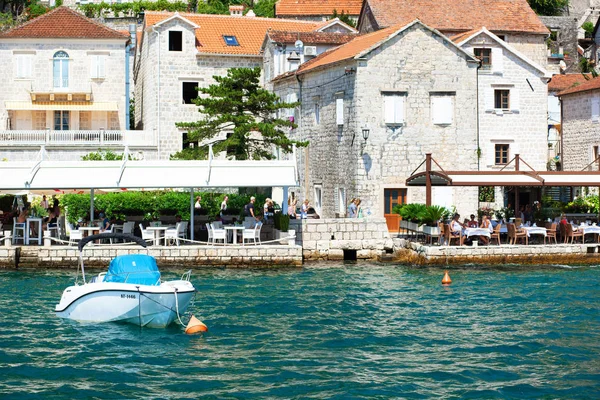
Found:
<box><xmin>394</xmin><ymin>239</ymin><xmax>600</xmax><ymax>265</ymax></box>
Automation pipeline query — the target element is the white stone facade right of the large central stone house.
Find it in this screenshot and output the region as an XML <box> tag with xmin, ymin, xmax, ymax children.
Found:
<box><xmin>461</xmin><ymin>31</ymin><xmax>549</xmax><ymax>175</ymax></box>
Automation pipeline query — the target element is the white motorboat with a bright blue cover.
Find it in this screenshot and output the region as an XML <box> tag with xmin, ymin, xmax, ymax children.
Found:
<box><xmin>55</xmin><ymin>233</ymin><xmax>196</xmax><ymax>328</ymax></box>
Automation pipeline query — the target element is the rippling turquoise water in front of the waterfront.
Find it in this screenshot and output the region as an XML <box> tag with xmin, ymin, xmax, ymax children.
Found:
<box><xmin>0</xmin><ymin>264</ymin><xmax>600</xmax><ymax>399</ymax></box>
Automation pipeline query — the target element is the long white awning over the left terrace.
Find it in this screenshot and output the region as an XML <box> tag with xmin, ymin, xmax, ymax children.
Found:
<box><xmin>0</xmin><ymin>160</ymin><xmax>298</xmax><ymax>193</ymax></box>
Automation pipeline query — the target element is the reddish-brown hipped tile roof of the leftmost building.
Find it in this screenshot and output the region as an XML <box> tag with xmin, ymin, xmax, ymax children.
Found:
<box><xmin>0</xmin><ymin>7</ymin><xmax>129</xmax><ymax>40</ymax></box>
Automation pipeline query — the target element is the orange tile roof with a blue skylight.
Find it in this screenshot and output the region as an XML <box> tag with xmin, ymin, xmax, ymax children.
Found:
<box><xmin>145</xmin><ymin>12</ymin><xmax>327</xmax><ymax>56</ymax></box>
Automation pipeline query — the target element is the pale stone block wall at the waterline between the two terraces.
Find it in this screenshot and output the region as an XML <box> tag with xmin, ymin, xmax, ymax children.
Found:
<box><xmin>297</xmin><ymin>218</ymin><xmax>393</xmax><ymax>260</ymax></box>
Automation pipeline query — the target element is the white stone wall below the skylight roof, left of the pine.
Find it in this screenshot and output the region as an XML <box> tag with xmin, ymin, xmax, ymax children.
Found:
<box><xmin>134</xmin><ymin>18</ymin><xmax>262</xmax><ymax>159</ymax></box>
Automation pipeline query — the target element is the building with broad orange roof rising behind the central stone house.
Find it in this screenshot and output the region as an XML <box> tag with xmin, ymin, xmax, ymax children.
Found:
<box><xmin>357</xmin><ymin>0</ymin><xmax>550</xmax><ymax>68</ymax></box>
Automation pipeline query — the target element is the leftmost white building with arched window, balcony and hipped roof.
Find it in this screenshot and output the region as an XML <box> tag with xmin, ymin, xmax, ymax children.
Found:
<box><xmin>0</xmin><ymin>7</ymin><xmax>152</xmax><ymax>160</ymax></box>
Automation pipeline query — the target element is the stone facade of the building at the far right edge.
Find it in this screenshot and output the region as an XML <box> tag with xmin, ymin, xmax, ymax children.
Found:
<box><xmin>561</xmin><ymin>89</ymin><xmax>600</xmax><ymax>171</ymax></box>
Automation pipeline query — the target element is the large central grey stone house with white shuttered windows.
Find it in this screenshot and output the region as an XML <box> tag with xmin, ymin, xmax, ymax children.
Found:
<box><xmin>273</xmin><ymin>20</ymin><xmax>479</xmax><ymax>223</ymax></box>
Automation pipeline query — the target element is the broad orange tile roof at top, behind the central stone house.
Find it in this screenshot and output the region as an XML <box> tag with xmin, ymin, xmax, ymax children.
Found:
<box><xmin>365</xmin><ymin>0</ymin><xmax>550</xmax><ymax>34</ymax></box>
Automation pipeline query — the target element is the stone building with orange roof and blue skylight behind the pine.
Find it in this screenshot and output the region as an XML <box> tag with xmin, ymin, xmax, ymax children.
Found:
<box><xmin>134</xmin><ymin>12</ymin><xmax>351</xmax><ymax>159</ymax></box>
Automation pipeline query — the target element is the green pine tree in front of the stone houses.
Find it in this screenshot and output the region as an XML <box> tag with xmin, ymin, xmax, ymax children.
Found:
<box><xmin>172</xmin><ymin>67</ymin><xmax>308</xmax><ymax>160</ymax></box>
